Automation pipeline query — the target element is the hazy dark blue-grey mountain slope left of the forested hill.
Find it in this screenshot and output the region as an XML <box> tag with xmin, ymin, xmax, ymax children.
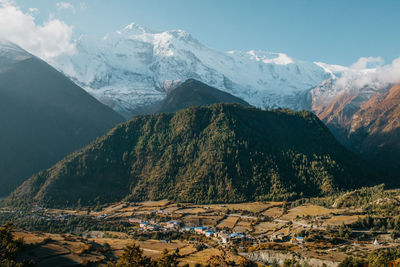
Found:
<box><xmin>0</xmin><ymin>40</ymin><xmax>124</xmax><ymax>196</ymax></box>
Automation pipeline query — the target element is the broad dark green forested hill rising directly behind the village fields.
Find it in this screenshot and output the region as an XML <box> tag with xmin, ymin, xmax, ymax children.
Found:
<box><xmin>10</xmin><ymin>104</ymin><xmax>375</xmax><ymax>206</ymax></box>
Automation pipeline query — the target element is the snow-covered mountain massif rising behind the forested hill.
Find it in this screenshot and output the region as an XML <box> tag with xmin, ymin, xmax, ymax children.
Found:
<box><xmin>50</xmin><ymin>23</ymin><xmax>340</xmax><ymax>116</ymax></box>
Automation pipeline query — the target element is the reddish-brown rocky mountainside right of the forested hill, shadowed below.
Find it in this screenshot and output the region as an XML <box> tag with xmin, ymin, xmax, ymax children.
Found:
<box><xmin>317</xmin><ymin>84</ymin><xmax>400</xmax><ymax>182</ymax></box>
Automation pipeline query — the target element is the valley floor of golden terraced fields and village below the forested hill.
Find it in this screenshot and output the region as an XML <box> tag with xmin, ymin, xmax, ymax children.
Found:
<box><xmin>0</xmin><ymin>200</ymin><xmax>399</xmax><ymax>266</ymax></box>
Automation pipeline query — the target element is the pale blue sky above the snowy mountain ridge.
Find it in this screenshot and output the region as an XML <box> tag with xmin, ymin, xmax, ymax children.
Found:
<box><xmin>10</xmin><ymin>0</ymin><xmax>400</xmax><ymax>65</ymax></box>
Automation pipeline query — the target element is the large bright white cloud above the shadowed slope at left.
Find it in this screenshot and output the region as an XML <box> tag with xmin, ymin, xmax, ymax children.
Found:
<box><xmin>0</xmin><ymin>0</ymin><xmax>75</xmax><ymax>60</ymax></box>
